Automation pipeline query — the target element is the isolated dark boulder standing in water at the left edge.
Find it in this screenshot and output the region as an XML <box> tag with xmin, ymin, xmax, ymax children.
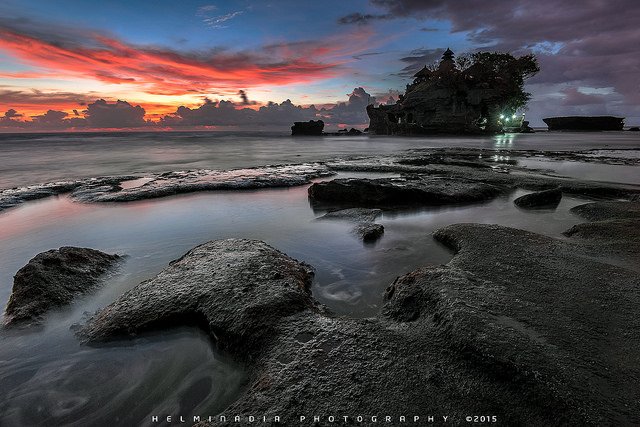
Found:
<box><xmin>5</xmin><ymin>247</ymin><xmax>121</xmax><ymax>327</ymax></box>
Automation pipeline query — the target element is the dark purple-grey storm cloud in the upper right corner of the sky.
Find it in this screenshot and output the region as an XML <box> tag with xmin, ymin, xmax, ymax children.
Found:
<box><xmin>345</xmin><ymin>0</ymin><xmax>640</xmax><ymax>110</ymax></box>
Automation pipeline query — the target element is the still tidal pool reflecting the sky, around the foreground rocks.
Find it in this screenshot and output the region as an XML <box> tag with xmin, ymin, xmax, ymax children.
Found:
<box><xmin>0</xmin><ymin>174</ymin><xmax>620</xmax><ymax>426</ymax></box>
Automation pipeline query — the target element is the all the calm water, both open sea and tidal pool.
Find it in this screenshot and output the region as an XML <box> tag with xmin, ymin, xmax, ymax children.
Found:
<box><xmin>0</xmin><ymin>133</ymin><xmax>640</xmax><ymax>426</ymax></box>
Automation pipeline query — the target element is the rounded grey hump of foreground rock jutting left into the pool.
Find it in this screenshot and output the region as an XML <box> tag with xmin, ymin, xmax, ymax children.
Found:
<box><xmin>79</xmin><ymin>239</ymin><xmax>318</xmax><ymax>357</ymax></box>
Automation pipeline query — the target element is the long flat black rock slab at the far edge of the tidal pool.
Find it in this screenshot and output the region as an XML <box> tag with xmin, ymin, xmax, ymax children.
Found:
<box><xmin>309</xmin><ymin>176</ymin><xmax>502</xmax><ymax>206</ymax></box>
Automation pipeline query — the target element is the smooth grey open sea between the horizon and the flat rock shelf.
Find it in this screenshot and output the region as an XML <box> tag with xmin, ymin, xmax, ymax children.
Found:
<box><xmin>0</xmin><ymin>132</ymin><xmax>640</xmax><ymax>188</ymax></box>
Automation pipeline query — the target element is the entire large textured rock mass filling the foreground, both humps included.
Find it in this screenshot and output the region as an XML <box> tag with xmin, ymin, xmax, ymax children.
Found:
<box><xmin>80</xmin><ymin>212</ymin><xmax>640</xmax><ymax>425</ymax></box>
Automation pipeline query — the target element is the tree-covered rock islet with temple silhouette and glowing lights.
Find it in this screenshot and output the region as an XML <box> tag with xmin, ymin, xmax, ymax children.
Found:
<box><xmin>367</xmin><ymin>49</ymin><xmax>539</xmax><ymax>135</ymax></box>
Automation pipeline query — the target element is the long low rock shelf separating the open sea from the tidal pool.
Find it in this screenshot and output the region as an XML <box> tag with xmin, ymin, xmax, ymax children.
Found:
<box><xmin>0</xmin><ymin>148</ymin><xmax>640</xmax><ymax>213</ymax></box>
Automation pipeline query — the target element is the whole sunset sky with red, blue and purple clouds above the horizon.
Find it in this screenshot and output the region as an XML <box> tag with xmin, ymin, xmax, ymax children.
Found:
<box><xmin>0</xmin><ymin>0</ymin><xmax>640</xmax><ymax>132</ymax></box>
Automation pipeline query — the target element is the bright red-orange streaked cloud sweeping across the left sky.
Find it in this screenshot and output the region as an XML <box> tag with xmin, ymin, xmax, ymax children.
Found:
<box><xmin>0</xmin><ymin>28</ymin><xmax>361</xmax><ymax>95</ymax></box>
